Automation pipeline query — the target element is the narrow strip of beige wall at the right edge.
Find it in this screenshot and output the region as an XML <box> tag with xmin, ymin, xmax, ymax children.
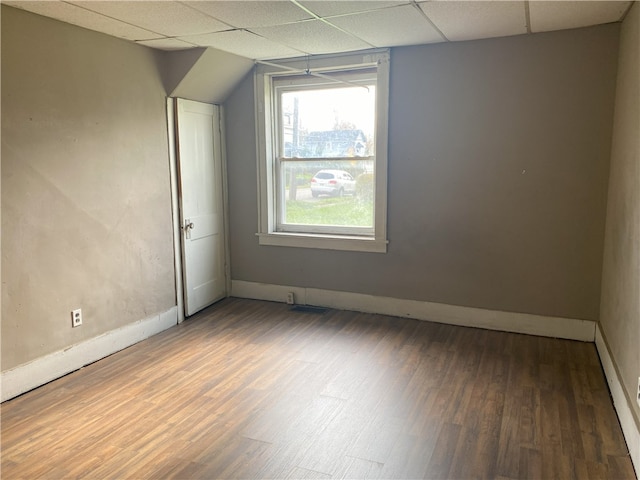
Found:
<box><xmin>600</xmin><ymin>3</ymin><xmax>640</xmax><ymax>423</ymax></box>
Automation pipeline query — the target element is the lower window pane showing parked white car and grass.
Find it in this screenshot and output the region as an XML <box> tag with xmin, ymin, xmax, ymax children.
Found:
<box><xmin>280</xmin><ymin>159</ymin><xmax>375</xmax><ymax>230</ymax></box>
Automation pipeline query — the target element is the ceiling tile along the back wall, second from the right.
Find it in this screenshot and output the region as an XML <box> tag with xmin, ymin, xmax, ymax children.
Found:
<box><xmin>418</xmin><ymin>1</ymin><xmax>527</xmax><ymax>40</ymax></box>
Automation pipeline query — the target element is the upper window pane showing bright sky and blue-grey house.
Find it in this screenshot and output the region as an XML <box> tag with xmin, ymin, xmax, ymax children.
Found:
<box><xmin>280</xmin><ymin>83</ymin><xmax>376</xmax><ymax>158</ymax></box>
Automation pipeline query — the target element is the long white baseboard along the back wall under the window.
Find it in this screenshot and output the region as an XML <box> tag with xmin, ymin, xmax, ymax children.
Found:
<box><xmin>231</xmin><ymin>280</ymin><xmax>596</xmax><ymax>342</ymax></box>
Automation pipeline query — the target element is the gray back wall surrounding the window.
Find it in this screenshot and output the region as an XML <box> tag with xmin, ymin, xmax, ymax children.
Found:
<box><xmin>225</xmin><ymin>25</ymin><xmax>619</xmax><ymax>320</ymax></box>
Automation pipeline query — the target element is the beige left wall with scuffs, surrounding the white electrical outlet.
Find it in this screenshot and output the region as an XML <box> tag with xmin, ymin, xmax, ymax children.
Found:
<box><xmin>1</xmin><ymin>6</ymin><xmax>176</xmax><ymax>371</ymax></box>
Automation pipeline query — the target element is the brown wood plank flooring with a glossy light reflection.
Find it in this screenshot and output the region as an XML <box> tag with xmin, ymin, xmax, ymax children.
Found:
<box><xmin>1</xmin><ymin>299</ymin><xmax>635</xmax><ymax>480</ymax></box>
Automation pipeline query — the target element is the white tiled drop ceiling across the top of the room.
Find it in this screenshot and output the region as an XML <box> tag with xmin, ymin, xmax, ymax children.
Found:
<box><xmin>2</xmin><ymin>0</ymin><xmax>633</xmax><ymax>60</ymax></box>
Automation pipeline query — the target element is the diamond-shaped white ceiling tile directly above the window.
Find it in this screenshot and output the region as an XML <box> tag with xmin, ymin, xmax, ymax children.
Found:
<box><xmin>251</xmin><ymin>20</ymin><xmax>372</xmax><ymax>54</ymax></box>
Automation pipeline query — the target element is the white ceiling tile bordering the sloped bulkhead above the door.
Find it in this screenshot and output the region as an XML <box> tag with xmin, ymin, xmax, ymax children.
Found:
<box><xmin>180</xmin><ymin>30</ymin><xmax>304</xmax><ymax>60</ymax></box>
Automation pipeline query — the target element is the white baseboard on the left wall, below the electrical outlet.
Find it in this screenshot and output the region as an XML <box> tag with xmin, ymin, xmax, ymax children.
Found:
<box><xmin>1</xmin><ymin>306</ymin><xmax>178</xmax><ymax>402</ymax></box>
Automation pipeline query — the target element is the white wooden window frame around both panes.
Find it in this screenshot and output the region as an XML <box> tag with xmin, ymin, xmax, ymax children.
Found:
<box><xmin>254</xmin><ymin>49</ymin><xmax>389</xmax><ymax>253</ymax></box>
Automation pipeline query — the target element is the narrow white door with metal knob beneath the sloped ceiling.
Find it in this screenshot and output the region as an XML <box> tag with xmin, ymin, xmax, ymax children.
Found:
<box><xmin>176</xmin><ymin>99</ymin><xmax>226</xmax><ymax>316</ymax></box>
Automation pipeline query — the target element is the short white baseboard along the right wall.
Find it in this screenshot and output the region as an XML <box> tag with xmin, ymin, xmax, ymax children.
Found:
<box><xmin>595</xmin><ymin>325</ymin><xmax>640</xmax><ymax>474</ymax></box>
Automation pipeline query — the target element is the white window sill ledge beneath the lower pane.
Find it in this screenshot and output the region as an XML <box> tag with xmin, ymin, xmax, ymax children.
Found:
<box><xmin>256</xmin><ymin>232</ymin><xmax>389</xmax><ymax>253</ymax></box>
